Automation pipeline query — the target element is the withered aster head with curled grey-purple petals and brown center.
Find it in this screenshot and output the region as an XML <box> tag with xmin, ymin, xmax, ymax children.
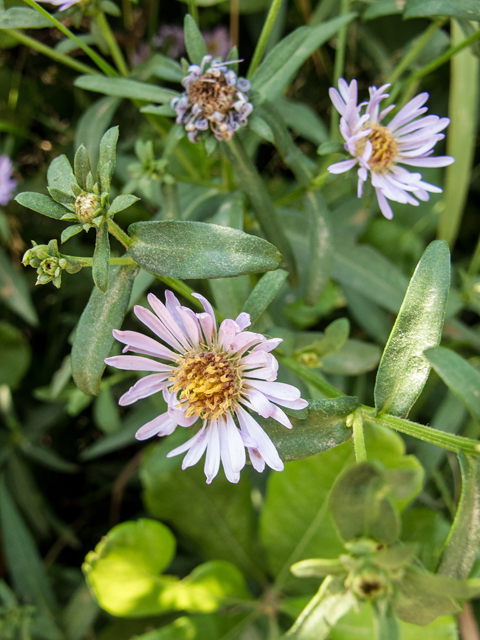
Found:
<box><xmin>171</xmin><ymin>55</ymin><xmax>253</xmax><ymax>142</ymax></box>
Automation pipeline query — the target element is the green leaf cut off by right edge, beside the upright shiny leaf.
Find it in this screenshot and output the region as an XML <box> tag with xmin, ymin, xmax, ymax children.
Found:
<box><xmin>425</xmin><ymin>347</ymin><xmax>480</xmax><ymax>420</ymax></box>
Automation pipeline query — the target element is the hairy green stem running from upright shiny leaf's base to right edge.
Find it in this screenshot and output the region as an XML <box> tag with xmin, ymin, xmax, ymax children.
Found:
<box><xmin>362</xmin><ymin>406</ymin><xmax>480</xmax><ymax>456</ymax></box>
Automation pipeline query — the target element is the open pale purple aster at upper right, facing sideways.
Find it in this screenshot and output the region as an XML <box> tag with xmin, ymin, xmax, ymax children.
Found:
<box><xmin>328</xmin><ymin>78</ymin><xmax>455</xmax><ymax>219</ymax></box>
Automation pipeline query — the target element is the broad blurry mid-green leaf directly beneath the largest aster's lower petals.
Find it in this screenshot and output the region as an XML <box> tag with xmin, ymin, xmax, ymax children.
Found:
<box><xmin>140</xmin><ymin>438</ymin><xmax>264</xmax><ymax>581</ymax></box>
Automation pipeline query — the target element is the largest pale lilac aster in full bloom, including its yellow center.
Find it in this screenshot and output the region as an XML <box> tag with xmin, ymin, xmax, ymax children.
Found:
<box><xmin>105</xmin><ymin>291</ymin><xmax>308</xmax><ymax>483</ymax></box>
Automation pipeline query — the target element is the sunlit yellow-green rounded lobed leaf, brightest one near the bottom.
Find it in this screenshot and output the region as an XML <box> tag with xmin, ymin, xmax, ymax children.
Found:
<box><xmin>82</xmin><ymin>518</ymin><xmax>249</xmax><ymax>618</ymax></box>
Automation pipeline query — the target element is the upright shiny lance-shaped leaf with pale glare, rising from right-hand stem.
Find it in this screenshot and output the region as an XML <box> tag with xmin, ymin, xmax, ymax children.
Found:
<box><xmin>375</xmin><ymin>240</ymin><xmax>450</xmax><ymax>418</ymax></box>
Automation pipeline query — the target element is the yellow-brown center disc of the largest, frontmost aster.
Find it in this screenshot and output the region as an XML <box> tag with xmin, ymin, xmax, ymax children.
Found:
<box><xmin>170</xmin><ymin>351</ymin><xmax>242</xmax><ymax>420</ymax></box>
